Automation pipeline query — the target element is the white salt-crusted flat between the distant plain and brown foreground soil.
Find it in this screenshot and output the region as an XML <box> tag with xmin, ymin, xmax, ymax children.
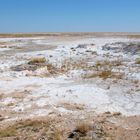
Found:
<box><xmin>0</xmin><ymin>33</ymin><xmax>140</xmax><ymax>139</ymax></box>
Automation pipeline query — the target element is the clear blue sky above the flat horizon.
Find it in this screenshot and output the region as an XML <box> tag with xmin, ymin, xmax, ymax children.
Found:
<box><xmin>0</xmin><ymin>0</ymin><xmax>140</xmax><ymax>33</ymax></box>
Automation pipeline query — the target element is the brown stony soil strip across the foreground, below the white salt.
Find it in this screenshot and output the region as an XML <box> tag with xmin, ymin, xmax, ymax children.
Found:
<box><xmin>0</xmin><ymin>112</ymin><xmax>140</xmax><ymax>140</ymax></box>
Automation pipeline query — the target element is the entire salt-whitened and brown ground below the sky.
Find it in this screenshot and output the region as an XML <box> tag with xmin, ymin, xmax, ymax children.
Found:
<box><xmin>0</xmin><ymin>33</ymin><xmax>140</xmax><ymax>140</ymax></box>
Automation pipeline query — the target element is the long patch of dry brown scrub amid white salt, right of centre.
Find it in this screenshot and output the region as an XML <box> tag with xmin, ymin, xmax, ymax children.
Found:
<box><xmin>47</xmin><ymin>59</ymin><xmax>124</xmax><ymax>79</ymax></box>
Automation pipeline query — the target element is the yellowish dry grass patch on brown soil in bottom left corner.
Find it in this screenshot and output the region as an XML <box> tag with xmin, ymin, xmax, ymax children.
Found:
<box><xmin>0</xmin><ymin>119</ymin><xmax>63</xmax><ymax>140</ymax></box>
